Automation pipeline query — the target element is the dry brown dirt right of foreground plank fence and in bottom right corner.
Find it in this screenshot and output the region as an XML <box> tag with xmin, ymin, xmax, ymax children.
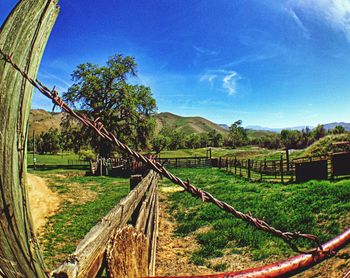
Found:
<box><xmin>156</xmin><ymin>187</ymin><xmax>350</xmax><ymax>278</ymax></box>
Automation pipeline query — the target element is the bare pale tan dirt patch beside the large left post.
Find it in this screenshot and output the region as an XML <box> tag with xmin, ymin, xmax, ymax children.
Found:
<box><xmin>28</xmin><ymin>174</ymin><xmax>60</xmax><ymax>233</ymax></box>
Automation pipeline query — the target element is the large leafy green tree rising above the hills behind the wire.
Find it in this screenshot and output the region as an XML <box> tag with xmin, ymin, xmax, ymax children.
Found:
<box><xmin>63</xmin><ymin>54</ymin><xmax>156</xmax><ymax>157</ymax></box>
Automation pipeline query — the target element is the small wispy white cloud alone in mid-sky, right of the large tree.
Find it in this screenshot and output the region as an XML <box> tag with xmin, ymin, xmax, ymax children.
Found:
<box><xmin>199</xmin><ymin>69</ymin><xmax>241</xmax><ymax>96</ymax></box>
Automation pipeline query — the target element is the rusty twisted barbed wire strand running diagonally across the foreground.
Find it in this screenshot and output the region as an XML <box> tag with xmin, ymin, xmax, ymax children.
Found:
<box><xmin>0</xmin><ymin>47</ymin><xmax>322</xmax><ymax>252</ymax></box>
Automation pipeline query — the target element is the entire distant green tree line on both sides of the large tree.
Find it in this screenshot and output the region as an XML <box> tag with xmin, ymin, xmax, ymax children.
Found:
<box><xmin>28</xmin><ymin>120</ymin><xmax>346</xmax><ymax>158</ymax></box>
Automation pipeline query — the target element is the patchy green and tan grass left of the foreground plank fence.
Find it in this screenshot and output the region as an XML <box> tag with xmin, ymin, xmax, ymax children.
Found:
<box><xmin>30</xmin><ymin>170</ymin><xmax>129</xmax><ymax>269</ymax></box>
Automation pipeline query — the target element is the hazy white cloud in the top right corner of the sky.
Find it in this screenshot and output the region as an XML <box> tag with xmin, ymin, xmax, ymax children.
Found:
<box><xmin>287</xmin><ymin>0</ymin><xmax>350</xmax><ymax>41</ymax></box>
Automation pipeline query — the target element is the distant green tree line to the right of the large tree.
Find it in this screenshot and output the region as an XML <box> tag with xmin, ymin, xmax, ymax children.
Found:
<box><xmin>152</xmin><ymin>120</ymin><xmax>346</xmax><ymax>153</ymax></box>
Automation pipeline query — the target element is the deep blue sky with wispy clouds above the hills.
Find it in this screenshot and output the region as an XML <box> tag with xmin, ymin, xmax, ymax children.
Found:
<box><xmin>0</xmin><ymin>0</ymin><xmax>350</xmax><ymax>127</ymax></box>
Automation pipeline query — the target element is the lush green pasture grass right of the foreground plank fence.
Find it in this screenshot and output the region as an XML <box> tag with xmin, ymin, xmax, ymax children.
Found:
<box><xmin>161</xmin><ymin>169</ymin><xmax>350</xmax><ymax>270</ymax></box>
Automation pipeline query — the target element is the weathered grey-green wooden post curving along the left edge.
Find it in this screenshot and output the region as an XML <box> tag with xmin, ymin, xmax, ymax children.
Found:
<box><xmin>0</xmin><ymin>0</ymin><xmax>59</xmax><ymax>277</ymax></box>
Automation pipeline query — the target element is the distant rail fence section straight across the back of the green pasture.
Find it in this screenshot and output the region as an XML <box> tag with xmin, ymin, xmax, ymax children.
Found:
<box><xmin>156</xmin><ymin>156</ymin><xmax>212</xmax><ymax>168</ymax></box>
